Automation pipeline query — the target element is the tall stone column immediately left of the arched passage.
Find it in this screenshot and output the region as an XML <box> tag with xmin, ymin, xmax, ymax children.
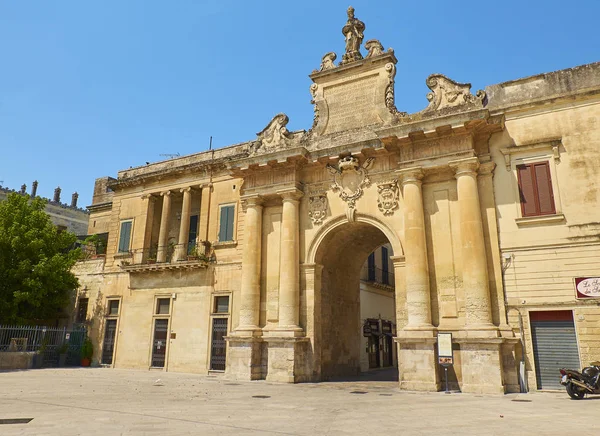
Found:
<box><xmin>278</xmin><ymin>189</ymin><xmax>303</xmax><ymax>336</ymax></box>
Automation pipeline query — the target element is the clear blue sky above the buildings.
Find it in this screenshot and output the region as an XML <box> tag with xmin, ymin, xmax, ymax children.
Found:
<box><xmin>0</xmin><ymin>0</ymin><xmax>600</xmax><ymax>205</ymax></box>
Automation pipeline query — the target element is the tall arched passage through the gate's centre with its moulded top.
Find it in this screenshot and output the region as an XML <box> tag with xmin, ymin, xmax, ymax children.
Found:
<box><xmin>309</xmin><ymin>216</ymin><xmax>401</xmax><ymax>380</ymax></box>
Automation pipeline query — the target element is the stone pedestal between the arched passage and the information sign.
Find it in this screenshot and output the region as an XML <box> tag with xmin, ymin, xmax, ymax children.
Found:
<box><xmin>394</xmin><ymin>332</ymin><xmax>440</xmax><ymax>392</ymax></box>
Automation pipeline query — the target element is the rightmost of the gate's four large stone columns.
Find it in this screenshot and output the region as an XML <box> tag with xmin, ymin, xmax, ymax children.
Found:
<box><xmin>449</xmin><ymin>157</ymin><xmax>495</xmax><ymax>330</ymax></box>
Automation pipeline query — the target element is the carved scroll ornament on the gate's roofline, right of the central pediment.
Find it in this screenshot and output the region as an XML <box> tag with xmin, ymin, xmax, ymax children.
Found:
<box><xmin>423</xmin><ymin>74</ymin><xmax>485</xmax><ymax>112</ymax></box>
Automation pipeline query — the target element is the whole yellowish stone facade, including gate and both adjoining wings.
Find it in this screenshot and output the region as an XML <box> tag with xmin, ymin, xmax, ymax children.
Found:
<box><xmin>77</xmin><ymin>10</ymin><xmax>600</xmax><ymax>393</ymax></box>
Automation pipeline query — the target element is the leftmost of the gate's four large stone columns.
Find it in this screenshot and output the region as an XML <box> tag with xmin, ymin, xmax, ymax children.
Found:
<box><xmin>236</xmin><ymin>196</ymin><xmax>263</xmax><ymax>336</ymax></box>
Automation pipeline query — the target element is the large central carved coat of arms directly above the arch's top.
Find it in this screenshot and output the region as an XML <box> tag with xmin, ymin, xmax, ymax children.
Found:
<box><xmin>327</xmin><ymin>156</ymin><xmax>375</xmax><ymax>221</ymax></box>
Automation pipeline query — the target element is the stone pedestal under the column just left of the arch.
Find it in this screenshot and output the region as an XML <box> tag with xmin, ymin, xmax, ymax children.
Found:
<box><xmin>263</xmin><ymin>338</ymin><xmax>312</xmax><ymax>383</ymax></box>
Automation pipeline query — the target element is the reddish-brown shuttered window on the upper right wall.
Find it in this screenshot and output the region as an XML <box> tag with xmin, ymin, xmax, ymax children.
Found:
<box><xmin>517</xmin><ymin>162</ymin><xmax>556</xmax><ymax>217</ymax></box>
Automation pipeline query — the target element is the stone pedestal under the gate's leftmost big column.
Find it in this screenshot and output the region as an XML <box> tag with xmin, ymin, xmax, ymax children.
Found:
<box><xmin>225</xmin><ymin>331</ymin><xmax>265</xmax><ymax>381</ymax></box>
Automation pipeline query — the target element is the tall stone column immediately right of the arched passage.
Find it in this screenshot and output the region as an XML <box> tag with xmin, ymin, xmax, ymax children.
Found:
<box><xmin>398</xmin><ymin>168</ymin><xmax>433</xmax><ymax>330</ymax></box>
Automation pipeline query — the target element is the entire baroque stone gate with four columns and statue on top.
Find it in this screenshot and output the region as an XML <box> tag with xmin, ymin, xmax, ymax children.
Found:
<box><xmin>227</xmin><ymin>8</ymin><xmax>517</xmax><ymax>392</ymax></box>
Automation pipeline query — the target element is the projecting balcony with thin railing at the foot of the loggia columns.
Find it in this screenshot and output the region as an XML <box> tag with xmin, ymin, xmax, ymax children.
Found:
<box><xmin>114</xmin><ymin>244</ymin><xmax>214</xmax><ymax>272</ymax></box>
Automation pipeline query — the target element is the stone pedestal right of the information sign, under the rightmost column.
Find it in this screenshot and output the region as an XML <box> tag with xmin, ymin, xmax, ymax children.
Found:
<box><xmin>455</xmin><ymin>338</ymin><xmax>505</xmax><ymax>394</ymax></box>
